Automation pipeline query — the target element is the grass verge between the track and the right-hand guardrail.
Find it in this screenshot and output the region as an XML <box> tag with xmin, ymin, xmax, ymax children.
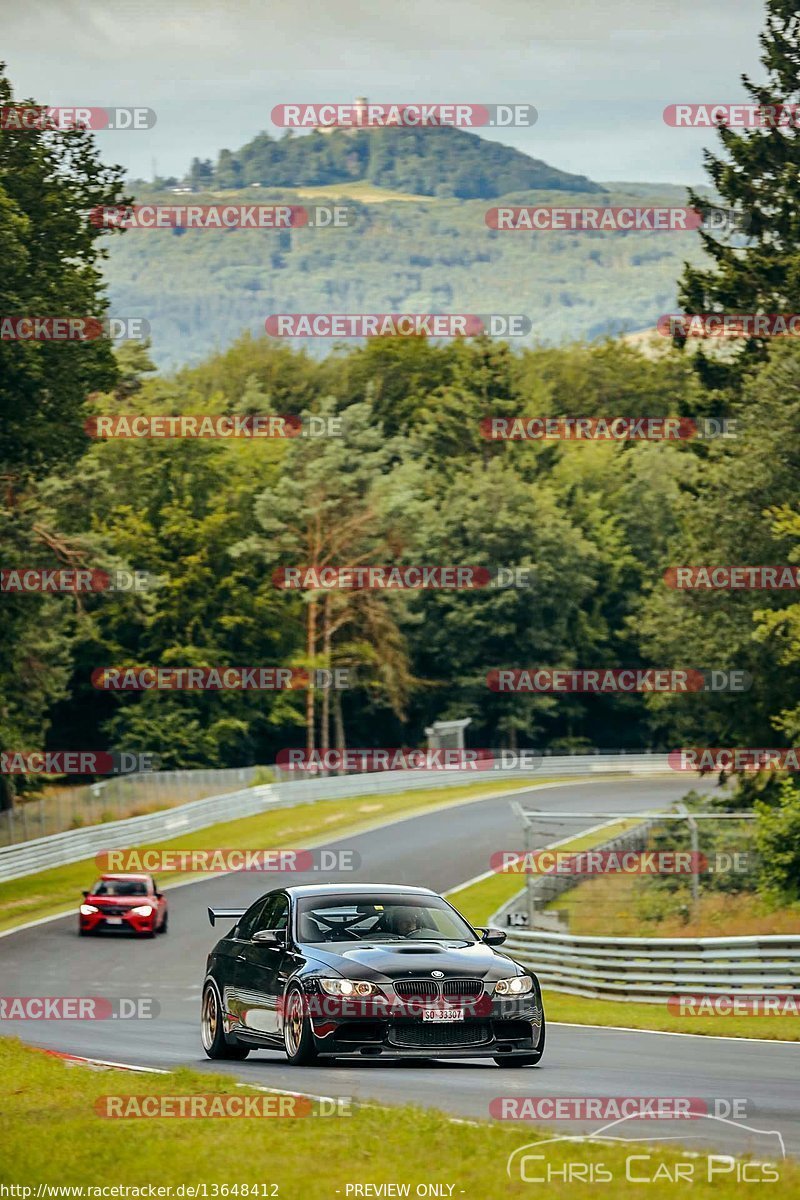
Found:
<box><xmin>447</xmin><ymin>821</ymin><xmax>800</xmax><ymax>1042</ymax></box>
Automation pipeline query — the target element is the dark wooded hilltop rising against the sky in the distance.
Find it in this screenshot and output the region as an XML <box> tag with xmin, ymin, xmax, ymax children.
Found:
<box><xmin>208</xmin><ymin>126</ymin><xmax>606</xmax><ymax>200</ymax></box>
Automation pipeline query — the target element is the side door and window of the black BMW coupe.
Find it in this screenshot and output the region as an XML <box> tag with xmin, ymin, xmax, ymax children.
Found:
<box><xmin>234</xmin><ymin>892</ymin><xmax>289</xmax><ymax>1037</ymax></box>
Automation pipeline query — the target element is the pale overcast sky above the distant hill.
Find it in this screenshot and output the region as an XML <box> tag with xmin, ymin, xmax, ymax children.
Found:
<box><xmin>0</xmin><ymin>0</ymin><xmax>763</xmax><ymax>184</ymax></box>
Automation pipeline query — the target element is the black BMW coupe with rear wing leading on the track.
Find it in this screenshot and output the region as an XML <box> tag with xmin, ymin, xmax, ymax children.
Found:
<box><xmin>200</xmin><ymin>883</ymin><xmax>545</xmax><ymax>1067</ymax></box>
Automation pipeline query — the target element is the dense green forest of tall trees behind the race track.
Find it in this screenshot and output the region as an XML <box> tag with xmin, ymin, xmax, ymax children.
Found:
<box><xmin>0</xmin><ymin>0</ymin><xmax>800</xmax><ymax>902</ymax></box>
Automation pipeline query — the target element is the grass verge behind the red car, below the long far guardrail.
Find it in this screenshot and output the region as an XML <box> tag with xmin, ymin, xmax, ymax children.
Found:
<box><xmin>0</xmin><ymin>779</ymin><xmax>552</xmax><ymax>930</ymax></box>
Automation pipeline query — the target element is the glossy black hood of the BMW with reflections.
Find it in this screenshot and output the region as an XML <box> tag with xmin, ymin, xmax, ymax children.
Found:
<box><xmin>297</xmin><ymin>941</ymin><xmax>519</xmax><ymax>980</ymax></box>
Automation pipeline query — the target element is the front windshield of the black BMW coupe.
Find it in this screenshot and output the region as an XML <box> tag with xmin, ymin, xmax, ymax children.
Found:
<box><xmin>297</xmin><ymin>893</ymin><xmax>476</xmax><ymax>942</ymax></box>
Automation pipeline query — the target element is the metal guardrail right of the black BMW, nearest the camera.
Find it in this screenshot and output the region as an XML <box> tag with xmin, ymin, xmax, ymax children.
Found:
<box><xmin>504</xmin><ymin>930</ymin><xmax>800</xmax><ymax>1004</ymax></box>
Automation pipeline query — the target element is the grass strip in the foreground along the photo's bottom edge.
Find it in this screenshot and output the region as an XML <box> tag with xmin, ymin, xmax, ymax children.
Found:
<box><xmin>0</xmin><ymin>1039</ymin><xmax>800</xmax><ymax>1200</ymax></box>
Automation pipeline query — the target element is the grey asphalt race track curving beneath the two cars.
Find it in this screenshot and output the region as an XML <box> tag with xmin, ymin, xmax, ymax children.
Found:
<box><xmin>0</xmin><ymin>778</ymin><xmax>800</xmax><ymax>1158</ymax></box>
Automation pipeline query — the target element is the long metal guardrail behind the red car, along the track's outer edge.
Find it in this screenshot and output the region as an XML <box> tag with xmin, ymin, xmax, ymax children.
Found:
<box><xmin>0</xmin><ymin>754</ymin><xmax>668</xmax><ymax>882</ymax></box>
